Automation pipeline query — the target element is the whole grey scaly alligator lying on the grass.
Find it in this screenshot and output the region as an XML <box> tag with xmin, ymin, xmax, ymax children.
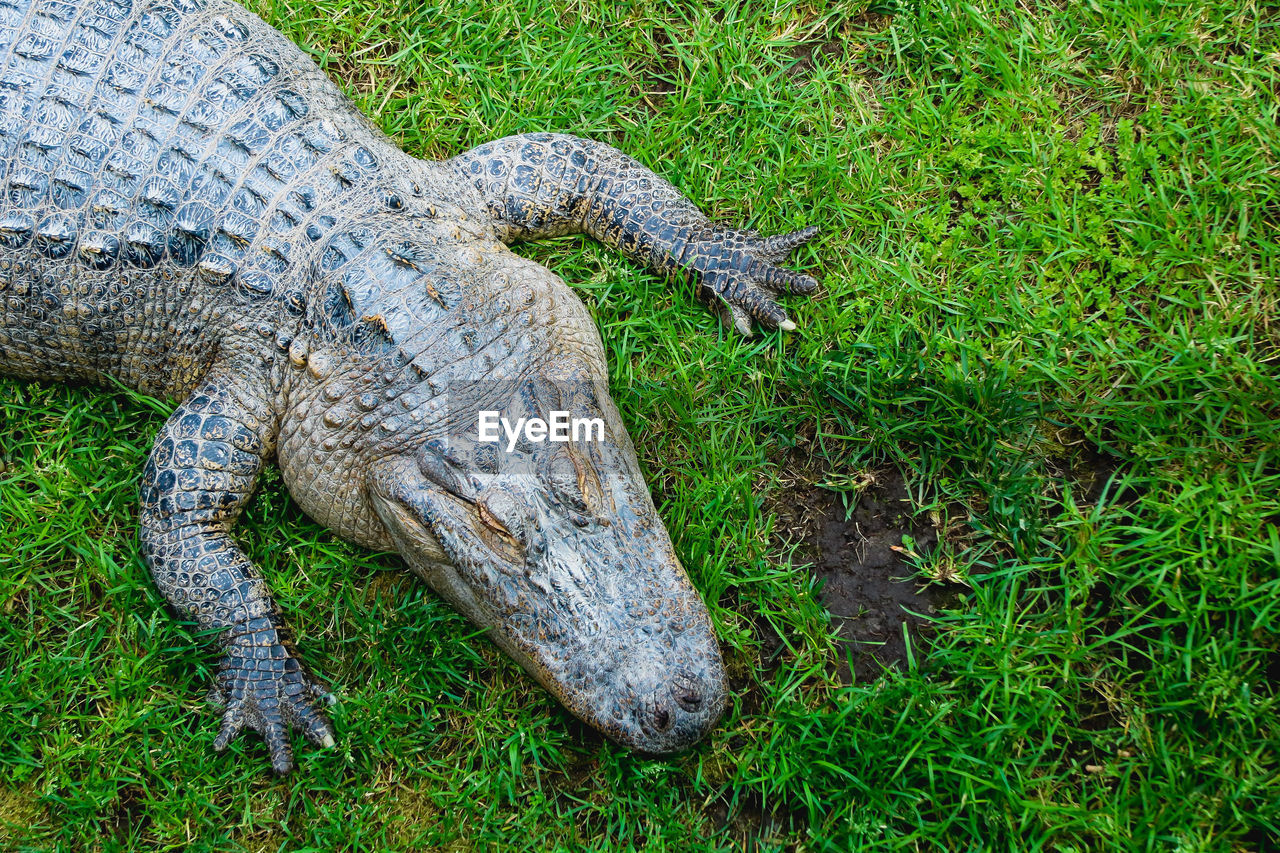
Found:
<box><xmin>0</xmin><ymin>0</ymin><xmax>818</xmax><ymax>774</ymax></box>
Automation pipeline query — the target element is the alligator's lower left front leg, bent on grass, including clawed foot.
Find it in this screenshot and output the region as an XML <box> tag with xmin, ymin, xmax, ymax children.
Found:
<box><xmin>141</xmin><ymin>365</ymin><xmax>334</xmax><ymax>774</ymax></box>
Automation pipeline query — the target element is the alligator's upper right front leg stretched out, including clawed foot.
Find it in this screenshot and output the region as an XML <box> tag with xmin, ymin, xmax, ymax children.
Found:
<box><xmin>449</xmin><ymin>133</ymin><xmax>818</xmax><ymax>336</ymax></box>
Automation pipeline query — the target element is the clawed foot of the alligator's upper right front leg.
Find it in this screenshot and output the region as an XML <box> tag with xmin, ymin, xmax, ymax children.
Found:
<box><xmin>685</xmin><ymin>225</ymin><xmax>818</xmax><ymax>337</ymax></box>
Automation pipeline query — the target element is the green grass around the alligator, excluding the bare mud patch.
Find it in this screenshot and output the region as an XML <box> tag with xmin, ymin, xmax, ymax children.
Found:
<box><xmin>0</xmin><ymin>0</ymin><xmax>1280</xmax><ymax>850</ymax></box>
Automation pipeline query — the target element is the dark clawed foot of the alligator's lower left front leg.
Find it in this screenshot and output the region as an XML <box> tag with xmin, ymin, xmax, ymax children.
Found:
<box><xmin>210</xmin><ymin>629</ymin><xmax>335</xmax><ymax>774</ymax></box>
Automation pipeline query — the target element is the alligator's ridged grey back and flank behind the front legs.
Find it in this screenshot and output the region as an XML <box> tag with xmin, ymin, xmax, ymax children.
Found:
<box><xmin>0</xmin><ymin>0</ymin><xmax>407</xmax><ymax>397</ymax></box>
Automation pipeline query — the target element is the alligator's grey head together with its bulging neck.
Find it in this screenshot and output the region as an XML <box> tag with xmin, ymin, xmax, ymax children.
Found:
<box><xmin>276</xmin><ymin>227</ymin><xmax>727</xmax><ymax>754</ymax></box>
